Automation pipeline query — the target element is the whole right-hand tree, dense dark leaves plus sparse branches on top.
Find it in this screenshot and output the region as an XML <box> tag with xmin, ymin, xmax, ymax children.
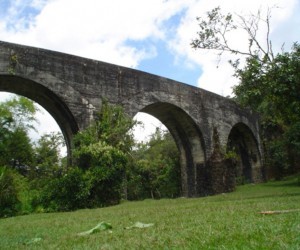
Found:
<box><xmin>191</xmin><ymin>7</ymin><xmax>300</xmax><ymax>178</ymax></box>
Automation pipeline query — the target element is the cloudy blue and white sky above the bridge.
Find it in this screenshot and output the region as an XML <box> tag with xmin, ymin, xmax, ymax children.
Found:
<box><xmin>0</xmin><ymin>0</ymin><xmax>300</xmax><ymax>144</ymax></box>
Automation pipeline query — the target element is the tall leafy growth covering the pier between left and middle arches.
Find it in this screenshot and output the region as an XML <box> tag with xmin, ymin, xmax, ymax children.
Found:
<box><xmin>73</xmin><ymin>101</ymin><xmax>136</xmax><ymax>206</ymax></box>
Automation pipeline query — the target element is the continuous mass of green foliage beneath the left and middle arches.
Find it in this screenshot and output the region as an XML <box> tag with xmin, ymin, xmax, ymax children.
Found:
<box><xmin>0</xmin><ymin>94</ymin><xmax>180</xmax><ymax>215</ymax></box>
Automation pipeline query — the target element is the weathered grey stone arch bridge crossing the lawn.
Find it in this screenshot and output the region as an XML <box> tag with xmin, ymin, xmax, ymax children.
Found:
<box><xmin>0</xmin><ymin>42</ymin><xmax>262</xmax><ymax>197</ymax></box>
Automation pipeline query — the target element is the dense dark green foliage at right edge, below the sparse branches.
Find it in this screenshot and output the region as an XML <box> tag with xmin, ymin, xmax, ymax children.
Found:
<box><xmin>234</xmin><ymin>43</ymin><xmax>300</xmax><ymax>178</ymax></box>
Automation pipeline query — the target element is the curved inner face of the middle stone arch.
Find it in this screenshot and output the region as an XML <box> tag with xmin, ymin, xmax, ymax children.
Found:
<box><xmin>140</xmin><ymin>102</ymin><xmax>206</xmax><ymax>197</ymax></box>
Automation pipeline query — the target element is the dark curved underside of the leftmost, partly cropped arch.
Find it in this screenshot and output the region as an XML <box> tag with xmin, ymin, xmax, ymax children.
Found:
<box><xmin>0</xmin><ymin>75</ymin><xmax>79</xmax><ymax>156</ymax></box>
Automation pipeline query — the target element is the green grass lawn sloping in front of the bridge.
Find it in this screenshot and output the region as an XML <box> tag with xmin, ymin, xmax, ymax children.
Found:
<box><xmin>0</xmin><ymin>178</ymin><xmax>300</xmax><ymax>250</ymax></box>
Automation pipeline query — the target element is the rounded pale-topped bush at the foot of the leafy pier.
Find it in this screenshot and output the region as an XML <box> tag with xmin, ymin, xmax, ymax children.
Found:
<box><xmin>74</xmin><ymin>141</ymin><xmax>128</xmax><ymax>207</ymax></box>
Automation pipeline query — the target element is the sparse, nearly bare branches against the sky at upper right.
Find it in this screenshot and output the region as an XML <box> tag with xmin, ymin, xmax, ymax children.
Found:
<box><xmin>191</xmin><ymin>7</ymin><xmax>274</xmax><ymax>61</ymax></box>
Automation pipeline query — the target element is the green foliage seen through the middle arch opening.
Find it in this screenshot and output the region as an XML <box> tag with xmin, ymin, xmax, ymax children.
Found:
<box><xmin>127</xmin><ymin>129</ymin><xmax>181</xmax><ymax>199</ymax></box>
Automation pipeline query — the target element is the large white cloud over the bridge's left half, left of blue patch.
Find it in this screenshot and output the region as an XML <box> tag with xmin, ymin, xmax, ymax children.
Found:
<box><xmin>0</xmin><ymin>0</ymin><xmax>188</xmax><ymax>67</ymax></box>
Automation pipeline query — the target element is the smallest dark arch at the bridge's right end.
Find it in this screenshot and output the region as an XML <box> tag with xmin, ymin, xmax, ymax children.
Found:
<box><xmin>227</xmin><ymin>122</ymin><xmax>262</xmax><ymax>183</ymax></box>
